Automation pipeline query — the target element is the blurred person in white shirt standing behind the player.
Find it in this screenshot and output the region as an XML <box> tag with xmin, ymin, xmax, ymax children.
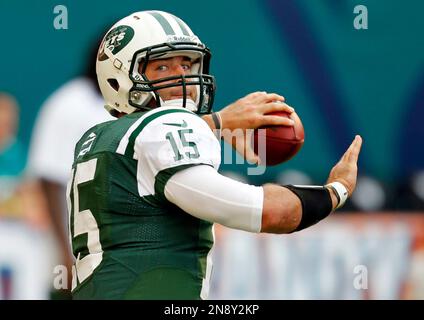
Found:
<box><xmin>28</xmin><ymin>31</ymin><xmax>114</xmax><ymax>296</ymax></box>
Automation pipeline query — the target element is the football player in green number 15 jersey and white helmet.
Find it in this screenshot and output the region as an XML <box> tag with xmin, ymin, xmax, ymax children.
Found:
<box><xmin>67</xmin><ymin>11</ymin><xmax>361</xmax><ymax>299</ymax></box>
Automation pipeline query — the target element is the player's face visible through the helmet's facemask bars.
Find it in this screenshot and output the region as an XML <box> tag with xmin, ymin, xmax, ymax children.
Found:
<box><xmin>141</xmin><ymin>56</ymin><xmax>196</xmax><ymax>101</ymax></box>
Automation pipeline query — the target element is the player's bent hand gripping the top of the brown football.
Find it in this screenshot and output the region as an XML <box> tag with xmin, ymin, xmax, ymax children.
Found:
<box><xmin>219</xmin><ymin>91</ymin><xmax>294</xmax><ymax>163</ymax></box>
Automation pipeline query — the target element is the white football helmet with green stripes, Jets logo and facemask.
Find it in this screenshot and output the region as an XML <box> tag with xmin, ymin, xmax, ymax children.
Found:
<box><xmin>96</xmin><ymin>11</ymin><xmax>215</xmax><ymax>116</ymax></box>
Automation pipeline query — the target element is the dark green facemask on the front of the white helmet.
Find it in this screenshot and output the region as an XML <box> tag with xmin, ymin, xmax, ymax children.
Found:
<box><xmin>128</xmin><ymin>42</ymin><xmax>215</xmax><ymax>114</ymax></box>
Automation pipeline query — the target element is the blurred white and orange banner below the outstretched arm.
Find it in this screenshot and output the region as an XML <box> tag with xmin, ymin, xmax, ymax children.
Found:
<box><xmin>209</xmin><ymin>213</ymin><xmax>424</xmax><ymax>299</ymax></box>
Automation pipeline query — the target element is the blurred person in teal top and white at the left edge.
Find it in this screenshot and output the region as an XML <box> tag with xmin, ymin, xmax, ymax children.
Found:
<box><xmin>0</xmin><ymin>93</ymin><xmax>51</xmax><ymax>299</ymax></box>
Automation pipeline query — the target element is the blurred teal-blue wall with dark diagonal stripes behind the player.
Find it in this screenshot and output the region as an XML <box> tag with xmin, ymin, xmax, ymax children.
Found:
<box><xmin>0</xmin><ymin>0</ymin><xmax>424</xmax><ymax>183</ymax></box>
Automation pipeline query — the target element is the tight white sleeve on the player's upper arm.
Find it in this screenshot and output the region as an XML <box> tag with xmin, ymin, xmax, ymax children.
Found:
<box><xmin>165</xmin><ymin>166</ymin><xmax>263</xmax><ymax>232</ymax></box>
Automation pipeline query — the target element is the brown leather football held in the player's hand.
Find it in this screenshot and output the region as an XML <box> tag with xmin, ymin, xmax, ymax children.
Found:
<box><xmin>252</xmin><ymin>111</ymin><xmax>305</xmax><ymax>166</ymax></box>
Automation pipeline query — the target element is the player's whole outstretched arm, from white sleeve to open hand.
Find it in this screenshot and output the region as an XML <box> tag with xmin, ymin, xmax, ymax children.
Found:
<box><xmin>165</xmin><ymin>137</ymin><xmax>362</xmax><ymax>233</ymax></box>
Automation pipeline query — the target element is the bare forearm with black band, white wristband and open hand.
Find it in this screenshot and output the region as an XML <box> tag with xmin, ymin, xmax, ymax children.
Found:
<box><xmin>261</xmin><ymin>136</ymin><xmax>362</xmax><ymax>233</ymax></box>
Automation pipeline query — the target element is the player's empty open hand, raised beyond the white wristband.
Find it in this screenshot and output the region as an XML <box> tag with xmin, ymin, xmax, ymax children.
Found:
<box><xmin>327</xmin><ymin>135</ymin><xmax>362</xmax><ymax>196</ymax></box>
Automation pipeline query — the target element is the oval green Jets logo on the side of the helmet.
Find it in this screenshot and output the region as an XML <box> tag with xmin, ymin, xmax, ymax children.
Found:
<box><xmin>97</xmin><ymin>25</ymin><xmax>134</xmax><ymax>61</ymax></box>
